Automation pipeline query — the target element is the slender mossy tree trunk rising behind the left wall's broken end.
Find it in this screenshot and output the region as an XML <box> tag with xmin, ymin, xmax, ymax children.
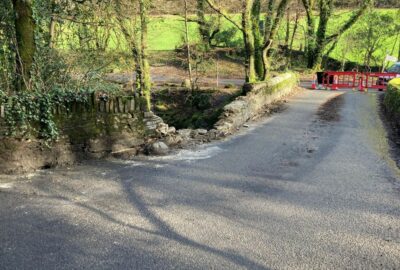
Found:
<box><xmin>139</xmin><ymin>0</ymin><xmax>151</xmax><ymax>111</ymax></box>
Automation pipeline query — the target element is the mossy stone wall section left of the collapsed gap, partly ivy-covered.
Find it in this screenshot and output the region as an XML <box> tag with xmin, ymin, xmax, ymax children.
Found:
<box><xmin>0</xmin><ymin>94</ymin><xmax>146</xmax><ymax>173</ymax></box>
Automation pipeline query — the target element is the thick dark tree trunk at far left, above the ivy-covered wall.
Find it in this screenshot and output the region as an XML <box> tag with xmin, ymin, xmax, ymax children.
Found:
<box><xmin>13</xmin><ymin>0</ymin><xmax>36</xmax><ymax>91</ymax></box>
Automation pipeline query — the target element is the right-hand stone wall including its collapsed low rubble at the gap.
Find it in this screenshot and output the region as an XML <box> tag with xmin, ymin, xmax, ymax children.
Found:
<box><xmin>148</xmin><ymin>73</ymin><xmax>298</xmax><ymax>154</ymax></box>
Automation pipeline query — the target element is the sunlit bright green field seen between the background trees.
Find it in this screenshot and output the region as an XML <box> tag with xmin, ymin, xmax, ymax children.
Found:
<box><xmin>58</xmin><ymin>9</ymin><xmax>400</xmax><ymax>71</ymax></box>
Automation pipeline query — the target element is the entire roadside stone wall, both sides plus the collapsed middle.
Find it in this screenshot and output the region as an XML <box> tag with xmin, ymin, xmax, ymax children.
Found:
<box><xmin>0</xmin><ymin>73</ymin><xmax>298</xmax><ymax>173</ymax></box>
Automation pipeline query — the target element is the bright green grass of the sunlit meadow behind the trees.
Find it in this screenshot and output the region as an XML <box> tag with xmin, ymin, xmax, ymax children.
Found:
<box><xmin>58</xmin><ymin>9</ymin><xmax>400</xmax><ymax>67</ymax></box>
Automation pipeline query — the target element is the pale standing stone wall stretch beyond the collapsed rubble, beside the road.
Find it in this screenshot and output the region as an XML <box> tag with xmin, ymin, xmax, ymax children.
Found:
<box><xmin>215</xmin><ymin>73</ymin><xmax>298</xmax><ymax>134</ymax></box>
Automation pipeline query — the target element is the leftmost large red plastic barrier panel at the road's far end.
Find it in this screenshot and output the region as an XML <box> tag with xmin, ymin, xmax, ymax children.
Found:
<box><xmin>322</xmin><ymin>71</ymin><xmax>359</xmax><ymax>90</ymax></box>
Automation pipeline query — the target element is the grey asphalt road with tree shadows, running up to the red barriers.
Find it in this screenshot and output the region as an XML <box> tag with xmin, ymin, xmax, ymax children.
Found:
<box><xmin>0</xmin><ymin>88</ymin><xmax>400</xmax><ymax>269</ymax></box>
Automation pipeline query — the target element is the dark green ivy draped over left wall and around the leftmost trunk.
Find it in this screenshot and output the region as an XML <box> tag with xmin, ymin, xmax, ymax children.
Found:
<box><xmin>0</xmin><ymin>0</ymin><xmax>125</xmax><ymax>141</ymax></box>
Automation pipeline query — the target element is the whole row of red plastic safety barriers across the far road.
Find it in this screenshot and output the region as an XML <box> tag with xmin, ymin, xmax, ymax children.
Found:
<box><xmin>313</xmin><ymin>71</ymin><xmax>400</xmax><ymax>91</ymax></box>
